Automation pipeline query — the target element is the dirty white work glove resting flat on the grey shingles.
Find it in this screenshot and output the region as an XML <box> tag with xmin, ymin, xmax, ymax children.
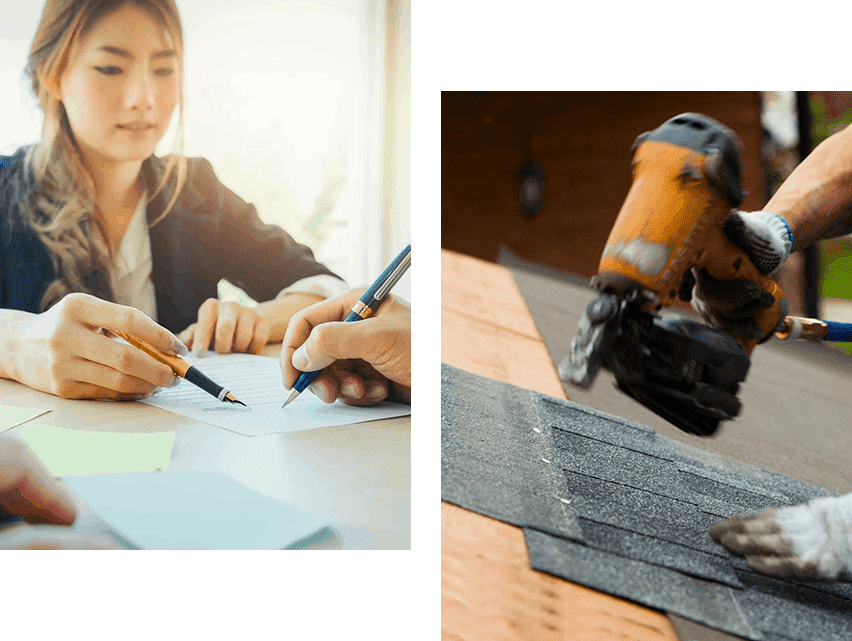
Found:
<box><xmin>710</xmin><ymin>494</ymin><xmax>852</xmax><ymax>582</ymax></box>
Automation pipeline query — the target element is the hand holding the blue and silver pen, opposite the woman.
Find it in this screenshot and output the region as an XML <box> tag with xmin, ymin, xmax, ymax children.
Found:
<box><xmin>281</xmin><ymin>287</ymin><xmax>411</xmax><ymax>405</ymax></box>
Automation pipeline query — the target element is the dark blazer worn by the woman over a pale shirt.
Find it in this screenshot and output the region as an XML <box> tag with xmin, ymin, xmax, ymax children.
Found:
<box><xmin>0</xmin><ymin>147</ymin><xmax>340</xmax><ymax>333</ymax></box>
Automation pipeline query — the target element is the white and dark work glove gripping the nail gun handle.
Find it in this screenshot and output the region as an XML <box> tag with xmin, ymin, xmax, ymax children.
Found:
<box><xmin>680</xmin><ymin>210</ymin><xmax>793</xmax><ymax>340</ymax></box>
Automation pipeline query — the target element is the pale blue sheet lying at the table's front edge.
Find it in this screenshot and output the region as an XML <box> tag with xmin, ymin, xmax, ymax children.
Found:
<box><xmin>63</xmin><ymin>471</ymin><xmax>332</xmax><ymax>550</ymax></box>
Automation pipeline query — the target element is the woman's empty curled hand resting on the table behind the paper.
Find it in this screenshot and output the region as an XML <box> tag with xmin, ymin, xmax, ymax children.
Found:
<box><xmin>178</xmin><ymin>298</ymin><xmax>271</xmax><ymax>354</ymax></box>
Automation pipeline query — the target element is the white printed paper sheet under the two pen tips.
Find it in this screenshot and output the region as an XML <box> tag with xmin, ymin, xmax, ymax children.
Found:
<box><xmin>140</xmin><ymin>352</ymin><xmax>411</xmax><ymax>436</ymax></box>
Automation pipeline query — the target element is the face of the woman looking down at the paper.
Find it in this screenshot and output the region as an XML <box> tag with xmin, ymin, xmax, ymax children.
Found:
<box><xmin>55</xmin><ymin>4</ymin><xmax>179</xmax><ymax>162</ymax></box>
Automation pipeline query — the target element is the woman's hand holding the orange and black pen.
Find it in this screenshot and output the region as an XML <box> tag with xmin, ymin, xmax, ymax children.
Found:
<box><xmin>9</xmin><ymin>294</ymin><xmax>186</xmax><ymax>400</ymax></box>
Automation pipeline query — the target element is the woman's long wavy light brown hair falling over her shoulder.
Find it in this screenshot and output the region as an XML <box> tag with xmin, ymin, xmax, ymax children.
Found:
<box><xmin>21</xmin><ymin>0</ymin><xmax>187</xmax><ymax>311</ymax></box>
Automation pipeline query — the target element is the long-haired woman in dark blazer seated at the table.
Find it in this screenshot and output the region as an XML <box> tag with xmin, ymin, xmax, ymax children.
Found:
<box><xmin>0</xmin><ymin>0</ymin><xmax>347</xmax><ymax>400</ymax></box>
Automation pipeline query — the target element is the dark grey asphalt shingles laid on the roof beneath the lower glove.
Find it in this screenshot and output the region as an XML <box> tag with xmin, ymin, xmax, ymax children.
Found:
<box><xmin>441</xmin><ymin>364</ymin><xmax>852</xmax><ymax>641</ymax></box>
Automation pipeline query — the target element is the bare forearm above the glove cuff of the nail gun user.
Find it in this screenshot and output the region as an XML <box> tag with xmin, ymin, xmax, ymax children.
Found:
<box><xmin>764</xmin><ymin>122</ymin><xmax>852</xmax><ymax>251</ymax></box>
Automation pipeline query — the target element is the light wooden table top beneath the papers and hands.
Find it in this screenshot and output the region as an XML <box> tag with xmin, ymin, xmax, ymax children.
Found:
<box><xmin>0</xmin><ymin>343</ymin><xmax>411</xmax><ymax>549</ymax></box>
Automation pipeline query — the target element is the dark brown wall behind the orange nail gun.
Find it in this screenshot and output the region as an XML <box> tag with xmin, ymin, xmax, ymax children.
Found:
<box><xmin>441</xmin><ymin>91</ymin><xmax>765</xmax><ymax>308</ymax></box>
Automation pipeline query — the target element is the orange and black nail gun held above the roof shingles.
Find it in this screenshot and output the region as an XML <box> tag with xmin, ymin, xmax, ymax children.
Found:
<box><xmin>559</xmin><ymin>113</ymin><xmax>787</xmax><ymax>436</ymax></box>
